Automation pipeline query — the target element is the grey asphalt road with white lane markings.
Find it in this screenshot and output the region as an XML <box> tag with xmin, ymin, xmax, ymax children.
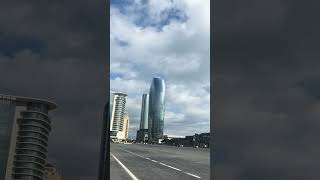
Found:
<box><xmin>110</xmin><ymin>143</ymin><xmax>210</xmax><ymax>180</ymax></box>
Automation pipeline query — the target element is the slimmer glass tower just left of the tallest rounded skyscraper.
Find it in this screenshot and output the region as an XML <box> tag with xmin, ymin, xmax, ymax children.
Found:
<box><xmin>136</xmin><ymin>94</ymin><xmax>149</xmax><ymax>142</ymax></box>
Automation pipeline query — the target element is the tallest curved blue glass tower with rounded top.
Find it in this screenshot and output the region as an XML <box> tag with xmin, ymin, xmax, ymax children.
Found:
<box><xmin>148</xmin><ymin>77</ymin><xmax>165</xmax><ymax>143</ymax></box>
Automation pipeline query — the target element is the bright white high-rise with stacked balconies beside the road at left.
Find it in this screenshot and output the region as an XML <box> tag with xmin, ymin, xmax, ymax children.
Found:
<box><xmin>110</xmin><ymin>92</ymin><xmax>127</xmax><ymax>139</ymax></box>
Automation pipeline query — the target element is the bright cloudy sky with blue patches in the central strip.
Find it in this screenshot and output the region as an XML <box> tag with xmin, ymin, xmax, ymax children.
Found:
<box><xmin>110</xmin><ymin>0</ymin><xmax>210</xmax><ymax>138</ymax></box>
